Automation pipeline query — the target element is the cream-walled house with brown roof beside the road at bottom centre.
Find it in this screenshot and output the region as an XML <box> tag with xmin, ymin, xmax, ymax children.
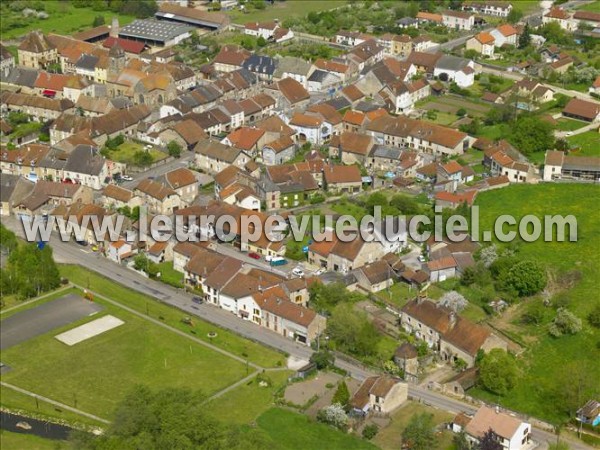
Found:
<box><xmin>350</xmin><ymin>375</ymin><xmax>408</xmax><ymax>415</ymax></box>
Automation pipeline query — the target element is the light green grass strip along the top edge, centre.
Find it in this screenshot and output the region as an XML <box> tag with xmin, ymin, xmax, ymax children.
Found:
<box><xmin>226</xmin><ymin>0</ymin><xmax>347</xmax><ymax>24</ymax></box>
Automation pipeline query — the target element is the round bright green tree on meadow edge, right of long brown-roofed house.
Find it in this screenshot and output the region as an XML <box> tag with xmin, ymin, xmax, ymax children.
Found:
<box><xmin>479</xmin><ymin>348</ymin><xmax>519</xmax><ymax>395</ymax></box>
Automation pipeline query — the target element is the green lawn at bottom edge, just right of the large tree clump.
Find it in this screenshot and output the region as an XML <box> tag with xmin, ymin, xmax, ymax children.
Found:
<box><xmin>257</xmin><ymin>408</ymin><xmax>376</xmax><ymax>450</ymax></box>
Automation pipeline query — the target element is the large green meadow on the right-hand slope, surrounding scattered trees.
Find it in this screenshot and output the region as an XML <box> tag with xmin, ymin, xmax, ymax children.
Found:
<box><xmin>470</xmin><ymin>184</ymin><xmax>600</xmax><ymax>421</ymax></box>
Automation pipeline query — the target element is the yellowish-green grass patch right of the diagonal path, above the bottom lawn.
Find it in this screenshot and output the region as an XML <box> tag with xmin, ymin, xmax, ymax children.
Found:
<box><xmin>207</xmin><ymin>370</ymin><xmax>293</xmax><ymax>425</ymax></box>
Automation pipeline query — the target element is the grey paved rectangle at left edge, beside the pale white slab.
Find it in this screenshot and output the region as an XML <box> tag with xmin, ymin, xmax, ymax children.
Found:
<box><xmin>0</xmin><ymin>294</ymin><xmax>104</xmax><ymax>350</ymax></box>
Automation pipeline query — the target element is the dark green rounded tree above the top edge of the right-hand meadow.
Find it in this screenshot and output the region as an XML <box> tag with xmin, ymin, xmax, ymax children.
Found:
<box><xmin>508</xmin><ymin>116</ymin><xmax>554</xmax><ymax>155</ymax></box>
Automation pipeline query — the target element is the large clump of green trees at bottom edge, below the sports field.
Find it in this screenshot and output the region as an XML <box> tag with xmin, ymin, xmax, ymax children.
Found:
<box><xmin>70</xmin><ymin>386</ymin><xmax>273</xmax><ymax>450</ymax></box>
